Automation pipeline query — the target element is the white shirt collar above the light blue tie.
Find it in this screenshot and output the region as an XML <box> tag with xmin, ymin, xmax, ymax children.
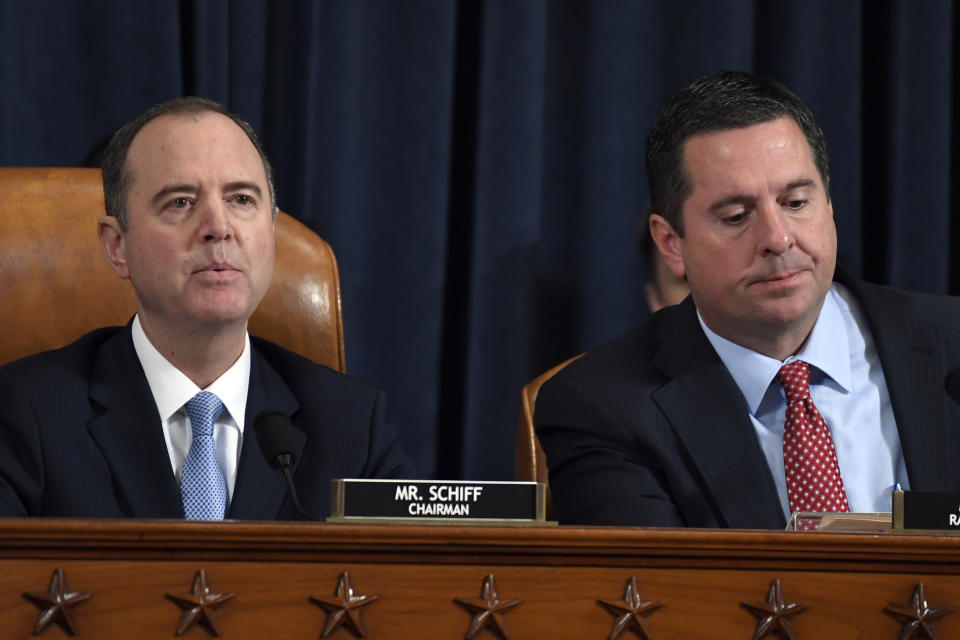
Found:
<box><xmin>131</xmin><ymin>314</ymin><xmax>250</xmax><ymax>434</ymax></box>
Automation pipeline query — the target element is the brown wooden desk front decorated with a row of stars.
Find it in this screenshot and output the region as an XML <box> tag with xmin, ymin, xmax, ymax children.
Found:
<box><xmin>0</xmin><ymin>520</ymin><xmax>960</xmax><ymax>640</ymax></box>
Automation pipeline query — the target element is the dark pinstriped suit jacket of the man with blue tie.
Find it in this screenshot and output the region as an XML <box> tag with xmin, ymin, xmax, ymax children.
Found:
<box><xmin>0</xmin><ymin>326</ymin><xmax>413</xmax><ymax>520</ymax></box>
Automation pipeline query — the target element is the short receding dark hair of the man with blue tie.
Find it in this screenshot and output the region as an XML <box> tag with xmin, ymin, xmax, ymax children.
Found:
<box><xmin>102</xmin><ymin>96</ymin><xmax>277</xmax><ymax>230</ymax></box>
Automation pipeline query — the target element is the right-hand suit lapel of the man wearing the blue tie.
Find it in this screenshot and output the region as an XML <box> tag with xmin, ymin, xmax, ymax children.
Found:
<box><xmin>229</xmin><ymin>347</ymin><xmax>307</xmax><ymax>520</ymax></box>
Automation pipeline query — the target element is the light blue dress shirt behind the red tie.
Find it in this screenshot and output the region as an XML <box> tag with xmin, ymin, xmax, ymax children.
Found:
<box><xmin>697</xmin><ymin>283</ymin><xmax>910</xmax><ymax>519</ymax></box>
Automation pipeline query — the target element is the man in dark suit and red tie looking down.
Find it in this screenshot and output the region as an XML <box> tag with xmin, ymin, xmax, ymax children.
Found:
<box><xmin>536</xmin><ymin>72</ymin><xmax>960</xmax><ymax>528</ymax></box>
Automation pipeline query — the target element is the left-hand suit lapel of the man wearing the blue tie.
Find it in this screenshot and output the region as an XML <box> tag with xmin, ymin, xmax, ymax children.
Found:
<box><xmin>87</xmin><ymin>326</ymin><xmax>183</xmax><ymax>518</ymax></box>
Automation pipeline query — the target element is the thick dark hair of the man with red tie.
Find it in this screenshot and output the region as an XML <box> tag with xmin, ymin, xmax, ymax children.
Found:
<box><xmin>646</xmin><ymin>71</ymin><xmax>830</xmax><ymax>237</ymax></box>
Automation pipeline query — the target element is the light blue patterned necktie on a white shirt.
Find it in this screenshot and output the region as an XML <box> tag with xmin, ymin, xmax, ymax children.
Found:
<box><xmin>180</xmin><ymin>391</ymin><xmax>227</xmax><ymax>520</ymax></box>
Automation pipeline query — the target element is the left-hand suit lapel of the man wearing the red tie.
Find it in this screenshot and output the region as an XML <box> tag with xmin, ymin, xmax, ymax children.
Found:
<box><xmin>653</xmin><ymin>298</ymin><xmax>786</xmax><ymax>529</ymax></box>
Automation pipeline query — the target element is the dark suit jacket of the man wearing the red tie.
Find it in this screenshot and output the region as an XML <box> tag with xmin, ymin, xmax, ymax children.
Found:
<box><xmin>535</xmin><ymin>278</ymin><xmax>960</xmax><ymax>529</ymax></box>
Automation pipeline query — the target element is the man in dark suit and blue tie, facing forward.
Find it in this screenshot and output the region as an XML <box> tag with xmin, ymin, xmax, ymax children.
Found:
<box><xmin>0</xmin><ymin>98</ymin><xmax>412</xmax><ymax>519</ymax></box>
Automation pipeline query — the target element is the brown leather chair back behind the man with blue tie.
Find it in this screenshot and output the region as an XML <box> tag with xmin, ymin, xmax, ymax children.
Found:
<box><xmin>0</xmin><ymin>168</ymin><xmax>346</xmax><ymax>371</ymax></box>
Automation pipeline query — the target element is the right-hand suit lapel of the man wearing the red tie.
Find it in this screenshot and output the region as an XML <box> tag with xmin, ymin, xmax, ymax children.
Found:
<box><xmin>841</xmin><ymin>276</ymin><xmax>960</xmax><ymax>491</ymax></box>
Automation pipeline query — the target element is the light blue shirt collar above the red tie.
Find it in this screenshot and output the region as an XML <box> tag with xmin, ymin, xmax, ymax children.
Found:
<box><xmin>697</xmin><ymin>284</ymin><xmax>852</xmax><ymax>415</ymax></box>
